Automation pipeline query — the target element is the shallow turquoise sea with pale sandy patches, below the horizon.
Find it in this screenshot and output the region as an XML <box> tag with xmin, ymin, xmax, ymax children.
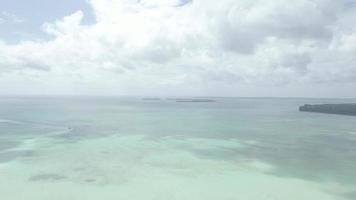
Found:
<box><xmin>0</xmin><ymin>97</ymin><xmax>356</xmax><ymax>200</ymax></box>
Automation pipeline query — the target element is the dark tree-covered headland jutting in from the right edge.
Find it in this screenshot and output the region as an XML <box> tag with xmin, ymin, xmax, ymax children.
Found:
<box><xmin>299</xmin><ymin>103</ymin><xmax>356</xmax><ymax>116</ymax></box>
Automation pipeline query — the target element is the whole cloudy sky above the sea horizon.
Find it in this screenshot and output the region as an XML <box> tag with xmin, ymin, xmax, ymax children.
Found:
<box><xmin>0</xmin><ymin>0</ymin><xmax>356</xmax><ymax>98</ymax></box>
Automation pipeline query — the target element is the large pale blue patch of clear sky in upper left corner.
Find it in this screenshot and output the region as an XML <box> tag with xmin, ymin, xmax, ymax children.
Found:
<box><xmin>0</xmin><ymin>0</ymin><xmax>95</xmax><ymax>43</ymax></box>
